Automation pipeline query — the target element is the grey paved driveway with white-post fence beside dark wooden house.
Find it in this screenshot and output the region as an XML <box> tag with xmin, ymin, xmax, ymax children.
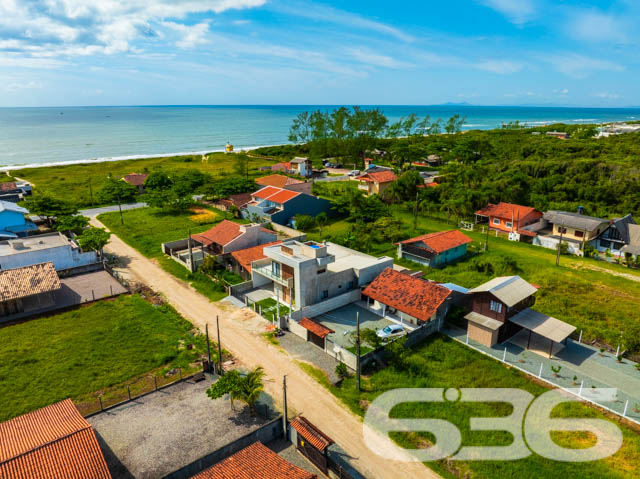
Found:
<box><xmin>442</xmin><ymin>324</ymin><xmax>640</xmax><ymax>423</ymax></box>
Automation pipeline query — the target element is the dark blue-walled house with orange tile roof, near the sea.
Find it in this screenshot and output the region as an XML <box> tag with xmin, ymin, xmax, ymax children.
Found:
<box><xmin>242</xmin><ymin>186</ymin><xmax>331</xmax><ymax>225</ymax></box>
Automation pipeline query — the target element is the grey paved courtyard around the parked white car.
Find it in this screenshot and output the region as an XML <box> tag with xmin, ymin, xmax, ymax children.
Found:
<box><xmin>313</xmin><ymin>303</ymin><xmax>395</xmax><ymax>348</ymax></box>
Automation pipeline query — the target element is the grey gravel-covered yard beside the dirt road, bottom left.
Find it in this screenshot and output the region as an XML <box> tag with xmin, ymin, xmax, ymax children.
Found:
<box><xmin>88</xmin><ymin>375</ymin><xmax>268</xmax><ymax>479</ymax></box>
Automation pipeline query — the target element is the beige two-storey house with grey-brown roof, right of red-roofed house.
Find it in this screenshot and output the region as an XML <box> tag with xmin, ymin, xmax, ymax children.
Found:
<box><xmin>532</xmin><ymin>211</ymin><xmax>611</xmax><ymax>254</ymax></box>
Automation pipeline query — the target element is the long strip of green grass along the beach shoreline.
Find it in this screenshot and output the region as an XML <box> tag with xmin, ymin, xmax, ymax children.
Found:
<box><xmin>12</xmin><ymin>153</ymin><xmax>273</xmax><ymax>208</ymax></box>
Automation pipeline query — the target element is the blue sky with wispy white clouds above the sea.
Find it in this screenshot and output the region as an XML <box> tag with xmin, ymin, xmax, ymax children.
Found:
<box><xmin>0</xmin><ymin>0</ymin><xmax>640</xmax><ymax>107</ymax></box>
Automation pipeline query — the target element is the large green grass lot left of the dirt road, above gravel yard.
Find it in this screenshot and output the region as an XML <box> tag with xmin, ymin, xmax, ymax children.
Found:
<box><xmin>0</xmin><ymin>295</ymin><xmax>208</xmax><ymax>421</ymax></box>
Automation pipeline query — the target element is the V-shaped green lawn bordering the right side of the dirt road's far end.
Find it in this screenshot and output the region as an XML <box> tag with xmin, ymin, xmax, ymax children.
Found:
<box><xmin>98</xmin><ymin>207</ymin><xmax>241</xmax><ymax>301</ymax></box>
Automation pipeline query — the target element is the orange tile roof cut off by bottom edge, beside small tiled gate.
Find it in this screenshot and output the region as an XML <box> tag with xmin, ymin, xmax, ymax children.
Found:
<box><xmin>192</xmin><ymin>442</ymin><xmax>317</xmax><ymax>479</ymax></box>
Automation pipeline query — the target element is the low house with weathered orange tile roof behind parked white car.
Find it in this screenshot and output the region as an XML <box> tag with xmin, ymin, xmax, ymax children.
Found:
<box><xmin>362</xmin><ymin>267</ymin><xmax>451</xmax><ymax>326</ymax></box>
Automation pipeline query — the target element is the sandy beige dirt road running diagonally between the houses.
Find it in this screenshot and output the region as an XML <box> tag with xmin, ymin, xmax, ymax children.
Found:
<box><xmin>91</xmin><ymin>218</ymin><xmax>440</xmax><ymax>479</ymax></box>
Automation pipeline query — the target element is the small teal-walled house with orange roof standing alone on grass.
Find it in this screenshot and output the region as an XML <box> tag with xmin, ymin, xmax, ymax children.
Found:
<box><xmin>396</xmin><ymin>230</ymin><xmax>472</xmax><ymax>268</ymax></box>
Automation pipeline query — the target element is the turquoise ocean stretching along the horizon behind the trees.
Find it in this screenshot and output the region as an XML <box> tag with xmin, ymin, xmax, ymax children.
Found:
<box><xmin>0</xmin><ymin>105</ymin><xmax>640</xmax><ymax>169</ymax></box>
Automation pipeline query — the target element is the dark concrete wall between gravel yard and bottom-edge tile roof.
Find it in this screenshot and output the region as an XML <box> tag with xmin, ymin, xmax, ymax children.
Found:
<box><xmin>164</xmin><ymin>416</ymin><xmax>284</xmax><ymax>479</ymax></box>
